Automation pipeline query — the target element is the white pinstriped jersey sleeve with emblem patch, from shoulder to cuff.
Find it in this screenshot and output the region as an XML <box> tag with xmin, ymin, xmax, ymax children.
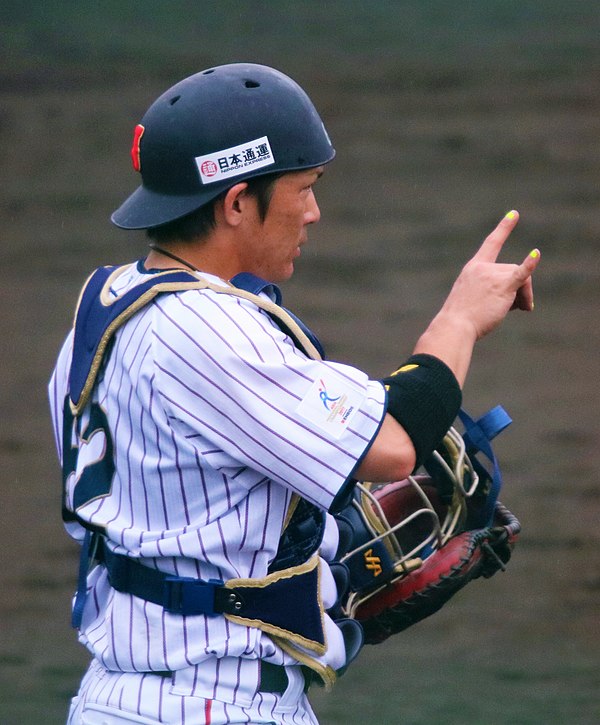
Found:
<box><xmin>153</xmin><ymin>291</ymin><xmax>385</xmax><ymax>509</ymax></box>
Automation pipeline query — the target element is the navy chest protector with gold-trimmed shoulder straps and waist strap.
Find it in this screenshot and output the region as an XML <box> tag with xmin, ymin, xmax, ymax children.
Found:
<box><xmin>63</xmin><ymin>267</ymin><xmax>346</xmax><ymax>685</ymax></box>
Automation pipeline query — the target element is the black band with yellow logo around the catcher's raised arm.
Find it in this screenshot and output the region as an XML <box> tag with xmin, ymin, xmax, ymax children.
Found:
<box><xmin>381</xmin><ymin>354</ymin><xmax>462</xmax><ymax>467</ymax></box>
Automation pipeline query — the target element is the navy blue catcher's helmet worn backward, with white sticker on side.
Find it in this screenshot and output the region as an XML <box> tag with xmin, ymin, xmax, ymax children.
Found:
<box><xmin>111</xmin><ymin>63</ymin><xmax>335</xmax><ymax>229</ymax></box>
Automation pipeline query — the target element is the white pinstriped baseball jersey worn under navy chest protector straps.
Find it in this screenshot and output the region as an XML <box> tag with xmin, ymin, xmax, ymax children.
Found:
<box><xmin>49</xmin><ymin>263</ymin><xmax>385</xmax><ymax>705</ymax></box>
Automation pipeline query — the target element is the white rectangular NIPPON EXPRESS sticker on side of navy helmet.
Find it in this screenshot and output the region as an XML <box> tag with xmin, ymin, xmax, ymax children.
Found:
<box><xmin>196</xmin><ymin>136</ymin><xmax>275</xmax><ymax>184</ymax></box>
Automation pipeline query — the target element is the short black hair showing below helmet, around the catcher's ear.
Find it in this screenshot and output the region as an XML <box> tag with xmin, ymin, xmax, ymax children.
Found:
<box><xmin>146</xmin><ymin>172</ymin><xmax>285</xmax><ymax>244</ymax></box>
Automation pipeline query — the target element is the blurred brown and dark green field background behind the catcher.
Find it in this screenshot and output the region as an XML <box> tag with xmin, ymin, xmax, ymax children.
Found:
<box><xmin>0</xmin><ymin>0</ymin><xmax>600</xmax><ymax>725</ymax></box>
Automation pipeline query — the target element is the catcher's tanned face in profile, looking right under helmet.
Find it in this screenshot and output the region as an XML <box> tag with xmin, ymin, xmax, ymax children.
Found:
<box><xmin>242</xmin><ymin>166</ymin><xmax>323</xmax><ymax>282</ymax></box>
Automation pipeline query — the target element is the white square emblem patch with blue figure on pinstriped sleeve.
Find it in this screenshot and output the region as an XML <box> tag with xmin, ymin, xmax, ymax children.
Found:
<box><xmin>296</xmin><ymin>371</ymin><xmax>365</xmax><ymax>438</ymax></box>
